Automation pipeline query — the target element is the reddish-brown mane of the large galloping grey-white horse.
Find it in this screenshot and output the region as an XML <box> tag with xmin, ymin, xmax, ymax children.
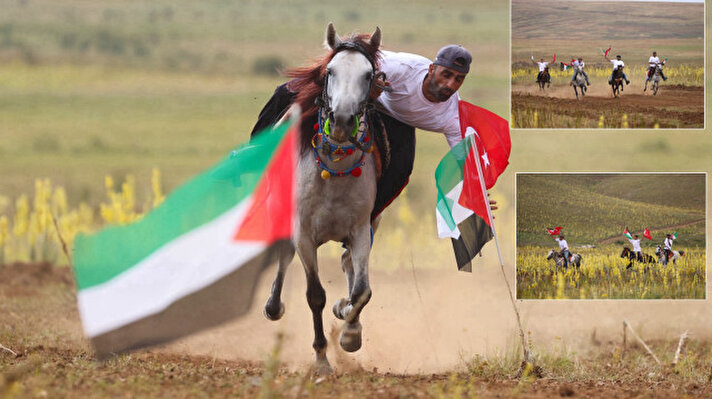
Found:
<box><xmin>286</xmin><ymin>34</ymin><xmax>381</xmax><ymax>150</ymax></box>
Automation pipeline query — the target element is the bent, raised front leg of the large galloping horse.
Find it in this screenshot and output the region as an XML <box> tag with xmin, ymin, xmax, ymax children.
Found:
<box><xmin>339</xmin><ymin>222</ymin><xmax>371</xmax><ymax>352</ymax></box>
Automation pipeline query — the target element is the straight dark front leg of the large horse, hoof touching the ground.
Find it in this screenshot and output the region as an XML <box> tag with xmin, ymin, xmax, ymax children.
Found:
<box><xmin>297</xmin><ymin>240</ymin><xmax>334</xmax><ymax>375</ymax></box>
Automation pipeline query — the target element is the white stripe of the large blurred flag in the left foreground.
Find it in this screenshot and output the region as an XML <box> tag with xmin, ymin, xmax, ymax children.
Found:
<box><xmin>77</xmin><ymin>196</ymin><xmax>268</xmax><ymax>337</ymax></box>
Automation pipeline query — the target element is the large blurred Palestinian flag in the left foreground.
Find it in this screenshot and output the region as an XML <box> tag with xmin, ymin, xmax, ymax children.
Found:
<box><xmin>74</xmin><ymin>121</ymin><xmax>296</xmax><ymax>358</ymax></box>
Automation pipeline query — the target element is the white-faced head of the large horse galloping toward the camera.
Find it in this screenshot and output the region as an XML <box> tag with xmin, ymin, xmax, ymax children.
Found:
<box><xmin>323</xmin><ymin>23</ymin><xmax>381</xmax><ymax>142</ymax></box>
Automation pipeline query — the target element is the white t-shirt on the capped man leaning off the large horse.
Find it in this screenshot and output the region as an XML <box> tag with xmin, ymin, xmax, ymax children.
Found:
<box><xmin>377</xmin><ymin>51</ymin><xmax>462</xmax><ymax>148</ymax></box>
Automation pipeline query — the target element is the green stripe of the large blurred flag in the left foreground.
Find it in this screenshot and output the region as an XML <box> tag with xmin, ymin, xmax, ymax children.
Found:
<box><xmin>74</xmin><ymin>124</ymin><xmax>289</xmax><ymax>290</ymax></box>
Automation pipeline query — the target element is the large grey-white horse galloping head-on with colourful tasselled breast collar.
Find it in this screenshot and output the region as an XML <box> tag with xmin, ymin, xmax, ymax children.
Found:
<box><xmin>264</xmin><ymin>23</ymin><xmax>381</xmax><ymax>375</ymax></box>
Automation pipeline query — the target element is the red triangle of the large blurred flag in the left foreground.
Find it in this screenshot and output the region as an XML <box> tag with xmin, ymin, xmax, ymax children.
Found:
<box><xmin>233</xmin><ymin>127</ymin><xmax>296</xmax><ymax>243</ymax></box>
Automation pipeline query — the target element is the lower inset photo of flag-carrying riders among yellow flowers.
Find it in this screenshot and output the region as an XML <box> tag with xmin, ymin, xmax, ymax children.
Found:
<box><xmin>515</xmin><ymin>173</ymin><xmax>707</xmax><ymax>300</ymax></box>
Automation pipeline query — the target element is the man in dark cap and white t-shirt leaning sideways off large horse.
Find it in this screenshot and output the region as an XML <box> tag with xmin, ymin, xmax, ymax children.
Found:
<box><xmin>251</xmin><ymin>44</ymin><xmax>497</xmax><ymax>220</ymax></box>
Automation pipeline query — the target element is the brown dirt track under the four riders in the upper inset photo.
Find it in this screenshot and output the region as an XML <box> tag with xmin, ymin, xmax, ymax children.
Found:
<box><xmin>512</xmin><ymin>83</ymin><xmax>704</xmax><ymax>128</ymax></box>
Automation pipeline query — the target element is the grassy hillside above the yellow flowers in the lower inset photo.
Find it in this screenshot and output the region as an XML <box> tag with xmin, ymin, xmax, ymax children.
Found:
<box><xmin>517</xmin><ymin>174</ymin><xmax>705</xmax><ymax>246</ymax></box>
